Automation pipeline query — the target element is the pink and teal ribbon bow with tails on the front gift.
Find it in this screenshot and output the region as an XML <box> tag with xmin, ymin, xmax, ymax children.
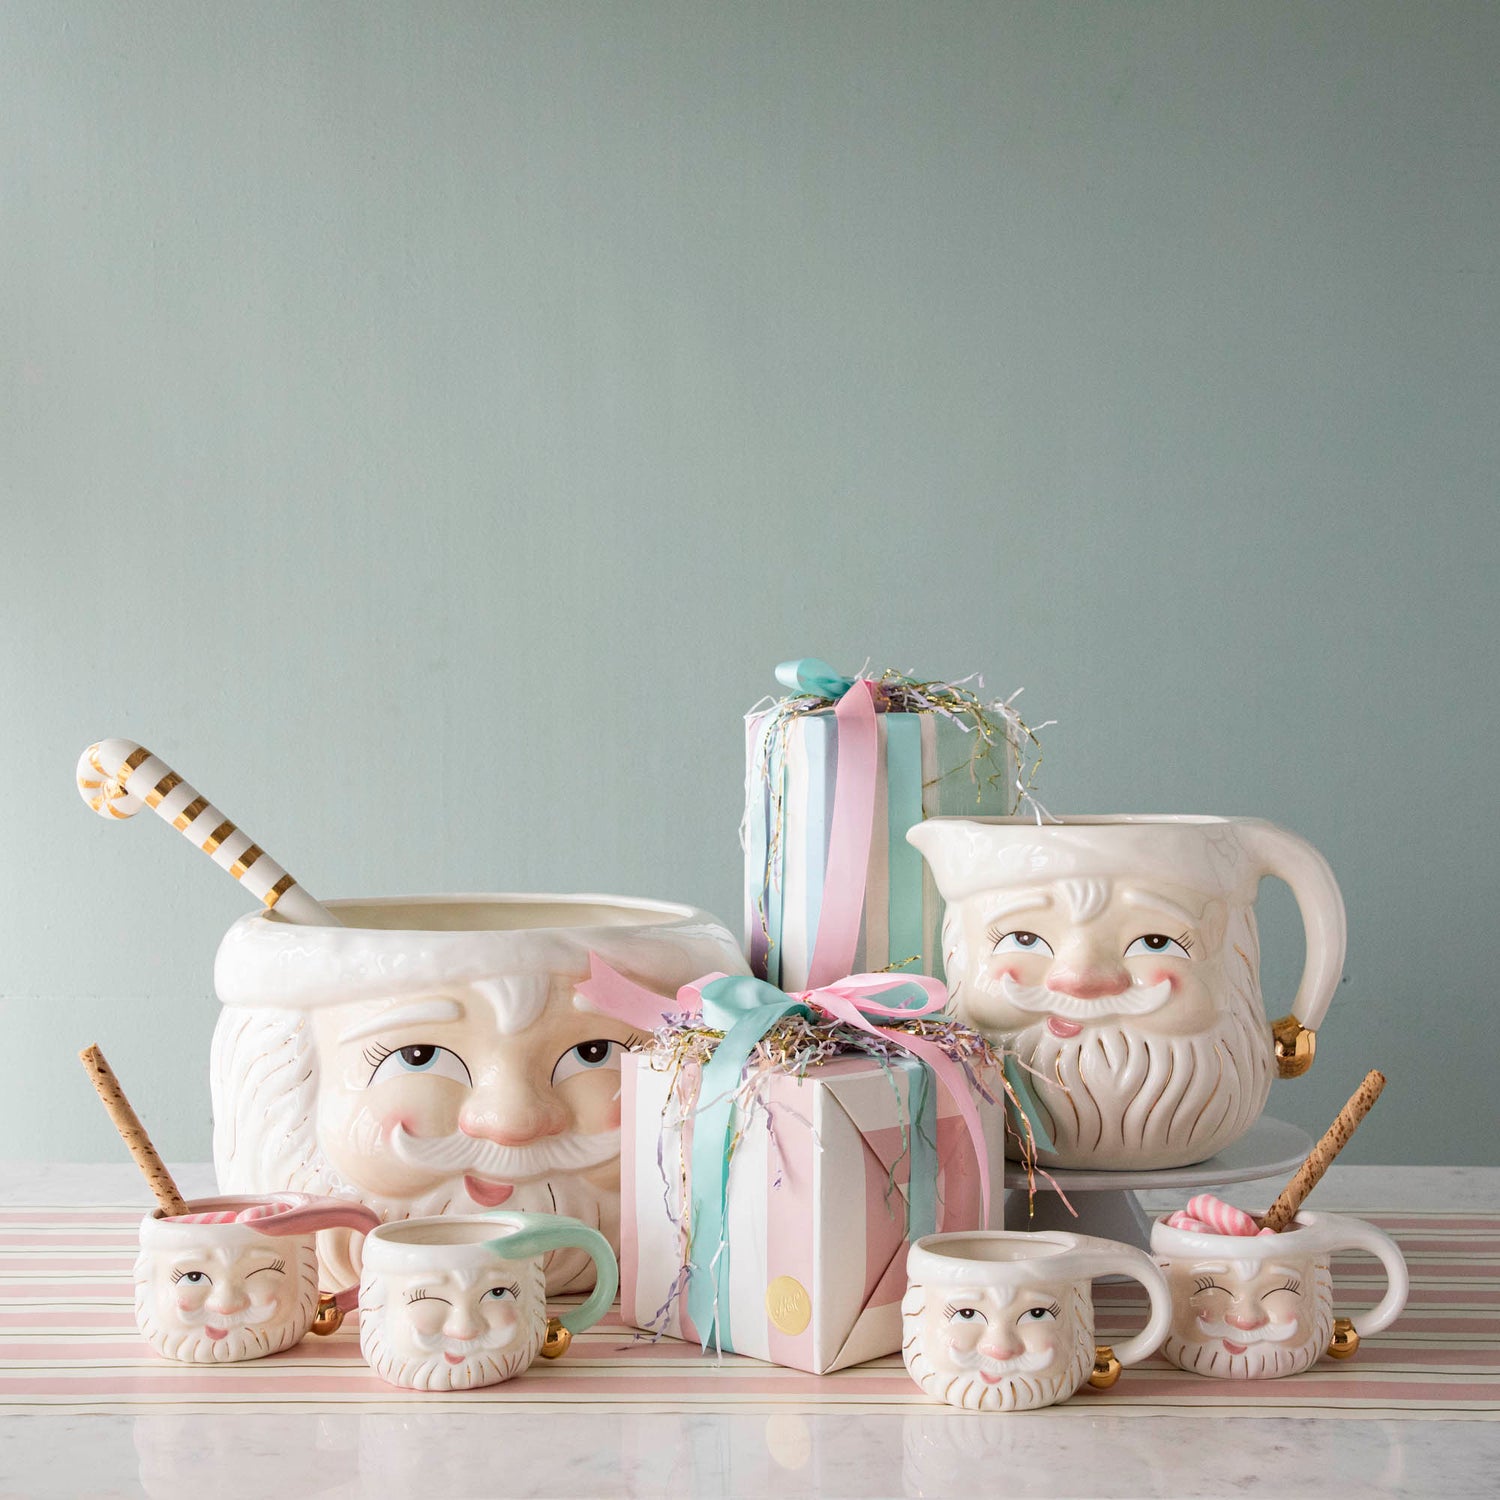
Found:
<box><xmin>578</xmin><ymin>954</ymin><xmax>990</xmax><ymax>1349</ymax></box>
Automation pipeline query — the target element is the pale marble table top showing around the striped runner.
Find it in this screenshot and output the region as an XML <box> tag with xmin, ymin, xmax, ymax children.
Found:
<box><xmin>0</xmin><ymin>1163</ymin><xmax>1500</xmax><ymax>1500</ymax></box>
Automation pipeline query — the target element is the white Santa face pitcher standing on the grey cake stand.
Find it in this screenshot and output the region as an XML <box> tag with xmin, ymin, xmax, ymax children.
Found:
<box><xmin>908</xmin><ymin>816</ymin><xmax>1344</xmax><ymax>1172</ymax></box>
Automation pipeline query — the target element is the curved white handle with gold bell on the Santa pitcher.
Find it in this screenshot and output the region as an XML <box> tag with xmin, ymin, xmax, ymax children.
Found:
<box><xmin>1238</xmin><ymin>819</ymin><xmax>1349</xmax><ymax>1079</ymax></box>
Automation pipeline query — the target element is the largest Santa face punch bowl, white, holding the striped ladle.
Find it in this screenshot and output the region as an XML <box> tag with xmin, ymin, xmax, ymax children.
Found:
<box><xmin>212</xmin><ymin>896</ymin><xmax>747</xmax><ymax>1293</ymax></box>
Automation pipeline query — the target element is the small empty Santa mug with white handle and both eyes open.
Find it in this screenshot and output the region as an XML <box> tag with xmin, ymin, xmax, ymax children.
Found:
<box><xmin>902</xmin><ymin>1230</ymin><xmax>1172</xmax><ymax>1412</ymax></box>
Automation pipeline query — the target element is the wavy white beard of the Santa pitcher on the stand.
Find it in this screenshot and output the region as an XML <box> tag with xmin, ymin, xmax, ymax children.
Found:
<box><xmin>1008</xmin><ymin>1002</ymin><xmax>1272</xmax><ymax>1170</ymax></box>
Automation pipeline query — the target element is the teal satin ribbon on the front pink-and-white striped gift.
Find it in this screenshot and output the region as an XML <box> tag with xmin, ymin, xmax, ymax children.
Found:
<box><xmin>687</xmin><ymin>975</ymin><xmax>938</xmax><ymax>1350</ymax></box>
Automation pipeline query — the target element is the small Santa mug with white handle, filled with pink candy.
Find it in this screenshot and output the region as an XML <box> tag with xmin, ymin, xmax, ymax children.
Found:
<box><xmin>1151</xmin><ymin>1214</ymin><xmax>1410</xmax><ymax>1380</ymax></box>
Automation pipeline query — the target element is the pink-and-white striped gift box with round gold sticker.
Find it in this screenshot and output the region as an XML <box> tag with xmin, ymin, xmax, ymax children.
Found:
<box><xmin>620</xmin><ymin>1053</ymin><xmax>1005</xmax><ymax>1374</ymax></box>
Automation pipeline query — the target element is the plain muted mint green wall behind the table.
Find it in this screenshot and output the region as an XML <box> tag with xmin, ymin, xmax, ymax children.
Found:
<box><xmin>0</xmin><ymin>0</ymin><xmax>1500</xmax><ymax>1164</ymax></box>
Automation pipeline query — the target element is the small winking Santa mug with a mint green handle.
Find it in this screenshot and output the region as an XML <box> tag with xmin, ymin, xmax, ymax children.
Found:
<box><xmin>360</xmin><ymin>1212</ymin><xmax>620</xmax><ymax>1391</ymax></box>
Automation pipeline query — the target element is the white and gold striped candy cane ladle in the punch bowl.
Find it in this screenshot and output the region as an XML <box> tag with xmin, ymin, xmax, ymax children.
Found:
<box><xmin>78</xmin><ymin>740</ymin><xmax>344</xmax><ymax>927</ymax></box>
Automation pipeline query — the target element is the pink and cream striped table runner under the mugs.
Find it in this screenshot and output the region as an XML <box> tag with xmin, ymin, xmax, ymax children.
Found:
<box><xmin>0</xmin><ymin>1206</ymin><xmax>1500</xmax><ymax>1421</ymax></box>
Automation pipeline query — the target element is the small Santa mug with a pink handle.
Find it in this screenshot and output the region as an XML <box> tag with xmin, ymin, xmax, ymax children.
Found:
<box><xmin>135</xmin><ymin>1193</ymin><xmax>378</xmax><ymax>1365</ymax></box>
